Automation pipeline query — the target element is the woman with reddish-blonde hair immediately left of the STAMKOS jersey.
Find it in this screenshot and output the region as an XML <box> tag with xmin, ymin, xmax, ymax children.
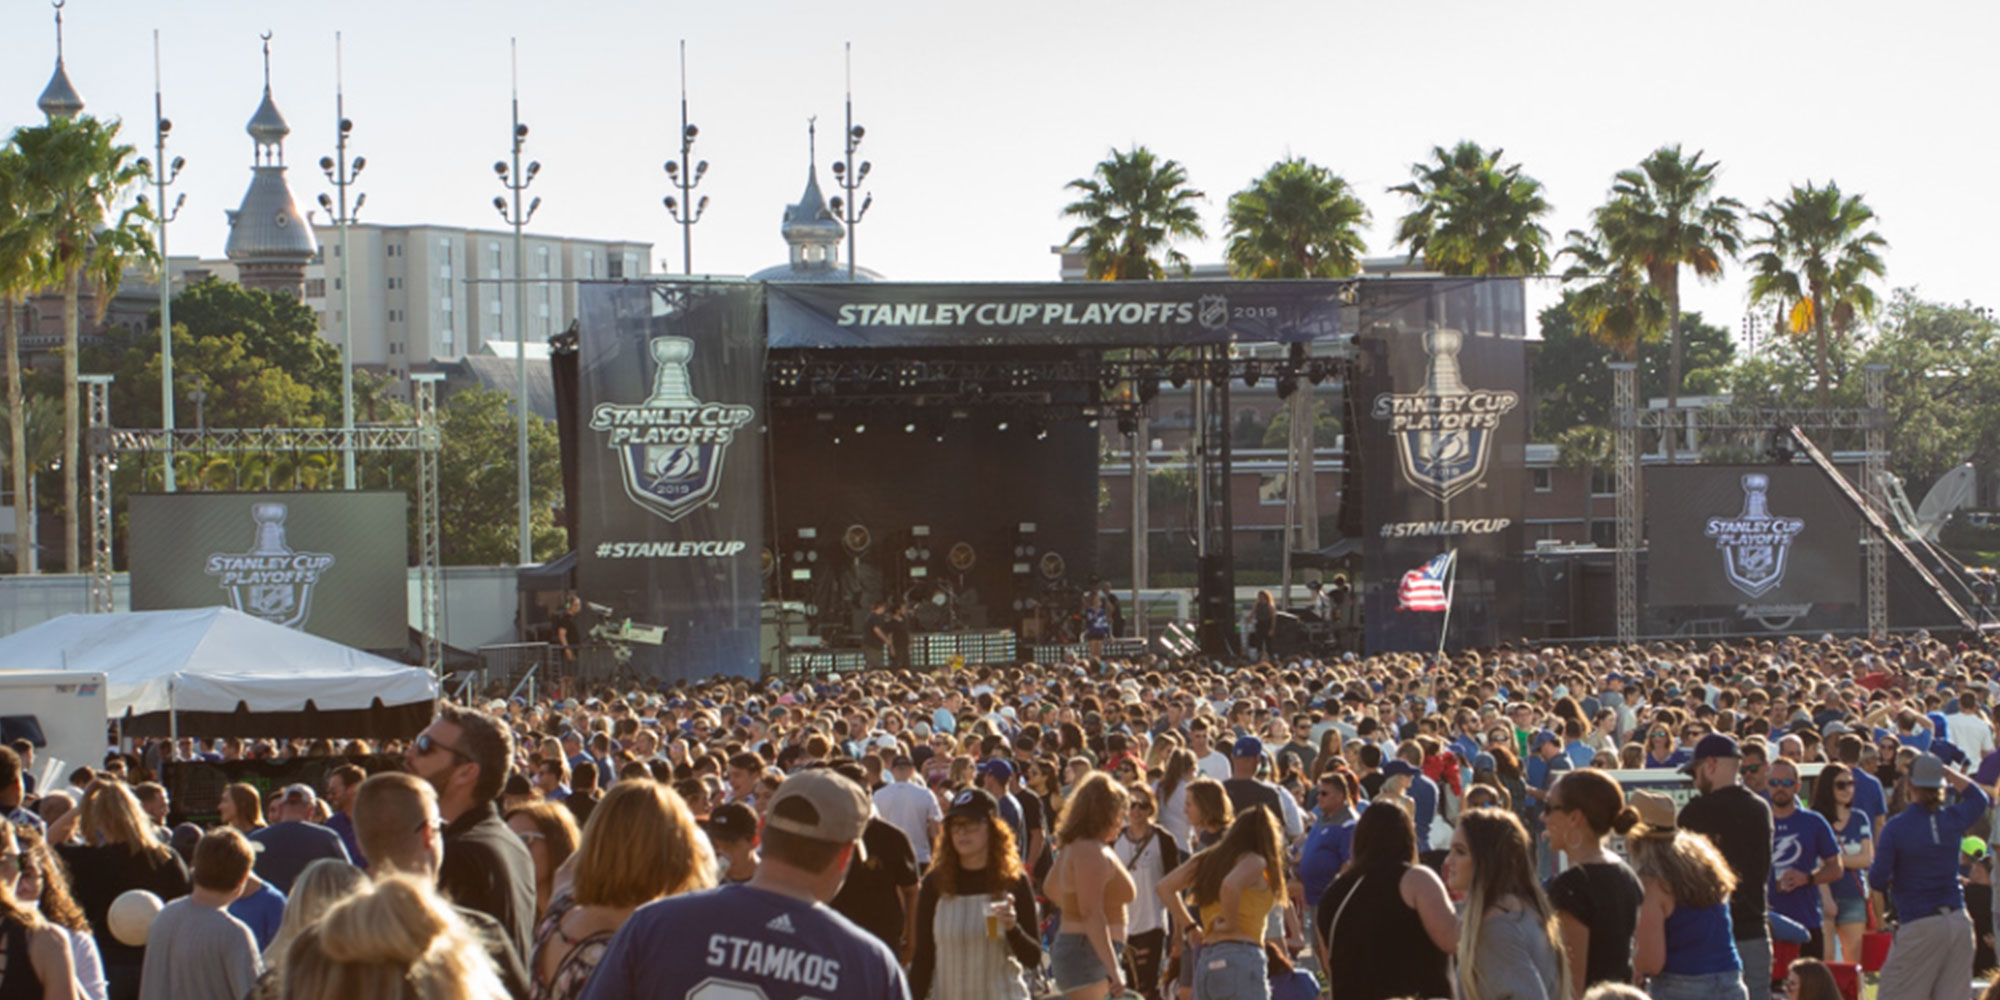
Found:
<box><xmin>528</xmin><ymin>780</ymin><xmax>716</xmax><ymax>1000</ymax></box>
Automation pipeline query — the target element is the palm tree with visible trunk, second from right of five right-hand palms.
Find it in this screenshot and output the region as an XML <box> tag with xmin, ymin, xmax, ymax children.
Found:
<box><xmin>1592</xmin><ymin>144</ymin><xmax>1744</xmax><ymax>434</ymax></box>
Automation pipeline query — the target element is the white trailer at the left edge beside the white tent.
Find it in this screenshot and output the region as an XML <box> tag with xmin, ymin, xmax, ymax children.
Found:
<box><xmin>0</xmin><ymin>670</ymin><xmax>112</xmax><ymax>788</ymax></box>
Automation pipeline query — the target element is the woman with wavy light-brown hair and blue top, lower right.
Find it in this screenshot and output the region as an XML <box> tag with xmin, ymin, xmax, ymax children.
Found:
<box><xmin>1626</xmin><ymin>790</ymin><xmax>1750</xmax><ymax>1000</ymax></box>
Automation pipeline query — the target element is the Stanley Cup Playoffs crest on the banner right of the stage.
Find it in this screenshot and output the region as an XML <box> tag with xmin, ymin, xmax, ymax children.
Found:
<box><xmin>1372</xmin><ymin>328</ymin><xmax>1520</xmax><ymax>502</ymax></box>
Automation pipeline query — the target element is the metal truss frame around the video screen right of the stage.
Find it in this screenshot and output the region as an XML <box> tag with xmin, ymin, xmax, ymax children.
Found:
<box><xmin>1610</xmin><ymin>362</ymin><xmax>1888</xmax><ymax>644</ymax></box>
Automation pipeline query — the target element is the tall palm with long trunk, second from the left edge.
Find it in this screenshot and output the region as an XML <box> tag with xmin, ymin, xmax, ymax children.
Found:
<box><xmin>14</xmin><ymin>116</ymin><xmax>158</xmax><ymax>572</ymax></box>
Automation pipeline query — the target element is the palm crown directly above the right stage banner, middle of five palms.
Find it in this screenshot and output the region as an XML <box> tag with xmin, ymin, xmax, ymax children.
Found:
<box><xmin>1390</xmin><ymin>142</ymin><xmax>1548</xmax><ymax>274</ymax></box>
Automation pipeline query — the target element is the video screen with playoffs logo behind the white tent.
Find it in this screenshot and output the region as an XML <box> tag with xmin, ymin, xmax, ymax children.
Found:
<box><xmin>126</xmin><ymin>490</ymin><xmax>410</xmax><ymax>650</ymax></box>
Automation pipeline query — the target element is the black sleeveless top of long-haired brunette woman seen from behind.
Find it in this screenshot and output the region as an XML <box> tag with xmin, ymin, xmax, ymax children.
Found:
<box><xmin>1316</xmin><ymin>864</ymin><xmax>1452</xmax><ymax>1000</ymax></box>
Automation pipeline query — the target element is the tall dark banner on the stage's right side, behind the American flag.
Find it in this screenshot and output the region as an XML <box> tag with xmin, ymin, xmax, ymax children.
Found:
<box><xmin>1346</xmin><ymin>278</ymin><xmax>1528</xmax><ymax>652</ymax></box>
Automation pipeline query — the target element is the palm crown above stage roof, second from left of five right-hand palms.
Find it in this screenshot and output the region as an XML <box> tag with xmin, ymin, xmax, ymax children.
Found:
<box><xmin>1228</xmin><ymin>158</ymin><xmax>1368</xmax><ymax>278</ymax></box>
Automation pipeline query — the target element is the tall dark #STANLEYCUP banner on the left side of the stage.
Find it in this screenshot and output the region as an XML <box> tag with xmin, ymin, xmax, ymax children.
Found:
<box><xmin>576</xmin><ymin>282</ymin><xmax>766</xmax><ymax>680</ymax></box>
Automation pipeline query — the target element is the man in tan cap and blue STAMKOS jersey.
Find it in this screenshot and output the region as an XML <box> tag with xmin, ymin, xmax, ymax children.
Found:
<box><xmin>584</xmin><ymin>768</ymin><xmax>910</xmax><ymax>1000</ymax></box>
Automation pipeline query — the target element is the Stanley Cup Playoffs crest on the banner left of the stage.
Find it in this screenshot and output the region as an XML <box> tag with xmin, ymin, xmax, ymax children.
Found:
<box><xmin>590</xmin><ymin>336</ymin><xmax>756</xmax><ymax>520</ymax></box>
